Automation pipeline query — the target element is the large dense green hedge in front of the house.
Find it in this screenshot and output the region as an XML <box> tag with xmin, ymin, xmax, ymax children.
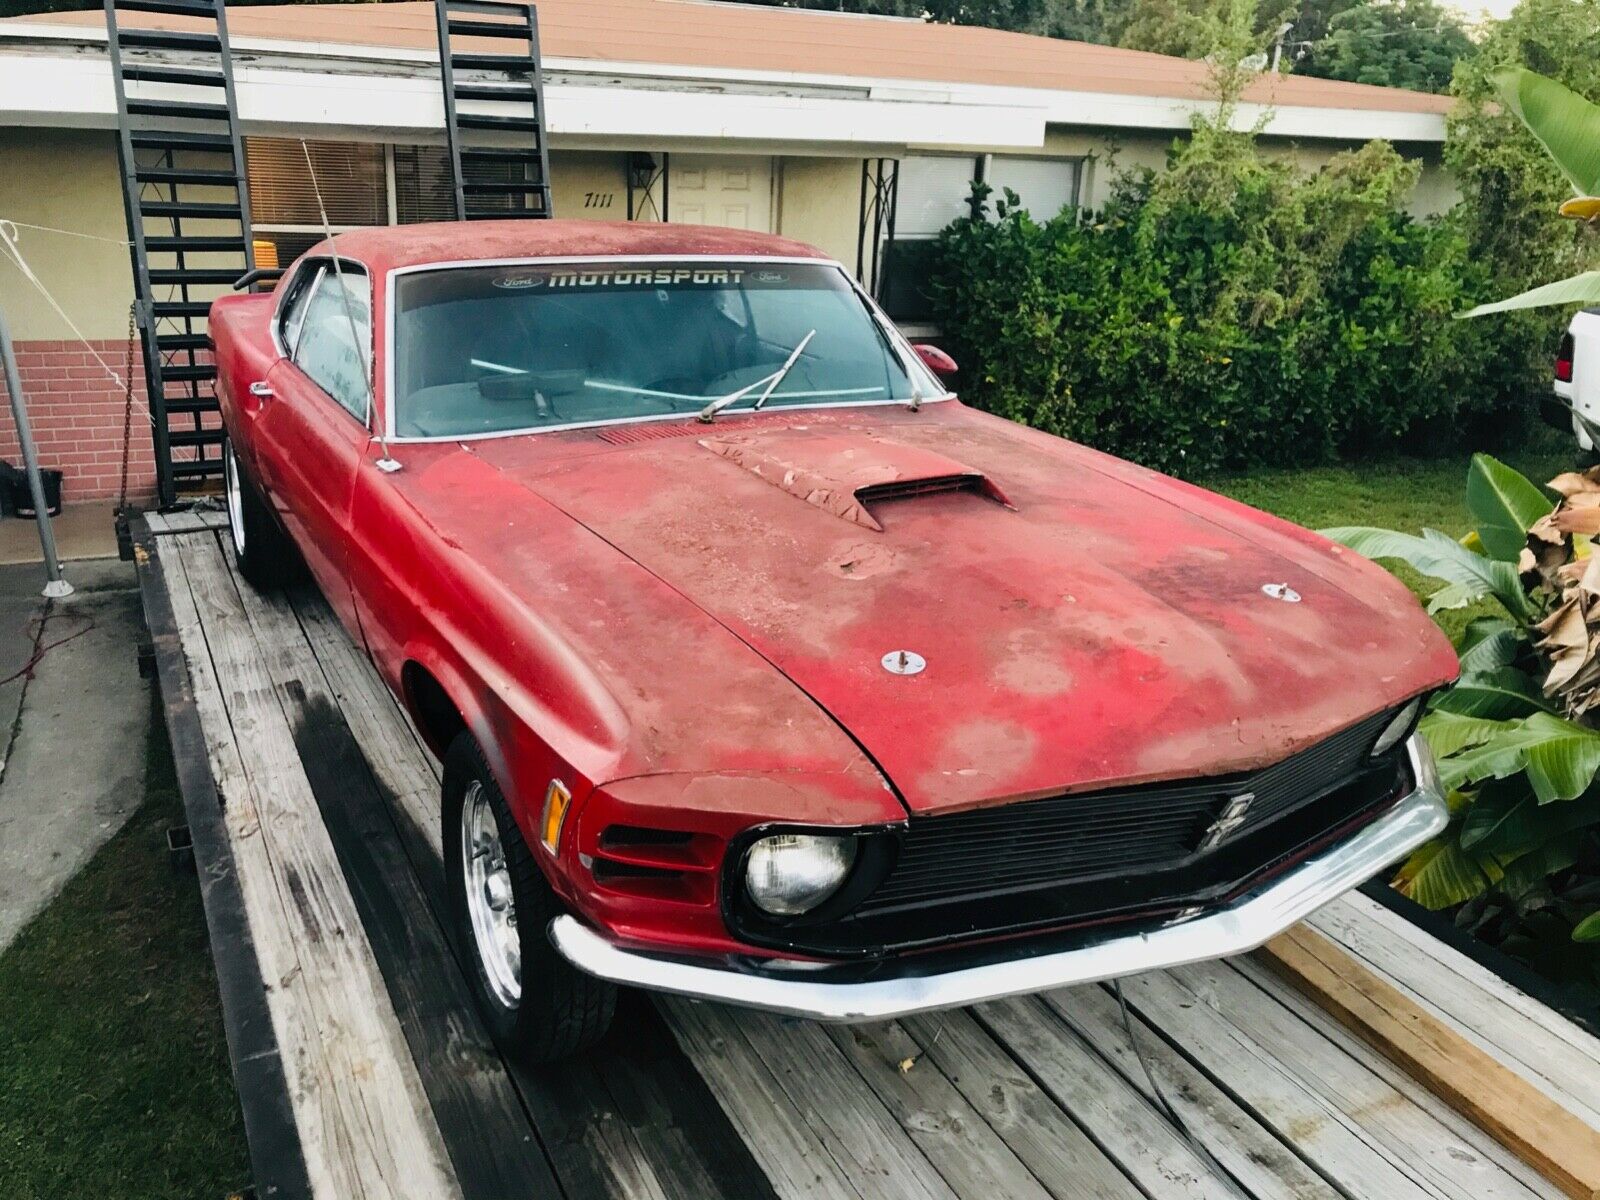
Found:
<box><xmin>930</xmin><ymin>138</ymin><xmax>1516</xmax><ymax>475</ymax></box>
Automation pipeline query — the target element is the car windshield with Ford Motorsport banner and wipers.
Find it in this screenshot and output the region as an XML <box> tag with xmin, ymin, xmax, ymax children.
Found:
<box><xmin>394</xmin><ymin>261</ymin><xmax>933</xmax><ymax>437</ymax></box>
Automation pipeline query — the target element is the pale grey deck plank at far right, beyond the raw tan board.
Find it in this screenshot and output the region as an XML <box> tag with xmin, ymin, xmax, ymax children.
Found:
<box><xmin>1307</xmin><ymin>893</ymin><xmax>1600</xmax><ymax>1131</ymax></box>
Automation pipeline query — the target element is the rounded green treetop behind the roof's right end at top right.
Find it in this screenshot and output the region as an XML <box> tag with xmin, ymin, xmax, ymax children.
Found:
<box><xmin>1291</xmin><ymin>0</ymin><xmax>1472</xmax><ymax>91</ymax></box>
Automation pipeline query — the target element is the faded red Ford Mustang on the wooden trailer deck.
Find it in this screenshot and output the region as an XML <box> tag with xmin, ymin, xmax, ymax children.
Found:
<box><xmin>211</xmin><ymin>221</ymin><xmax>1456</xmax><ymax>1058</ymax></box>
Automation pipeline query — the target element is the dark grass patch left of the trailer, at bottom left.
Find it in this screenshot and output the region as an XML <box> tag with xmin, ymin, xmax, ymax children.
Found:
<box><xmin>0</xmin><ymin>700</ymin><xmax>250</xmax><ymax>1200</ymax></box>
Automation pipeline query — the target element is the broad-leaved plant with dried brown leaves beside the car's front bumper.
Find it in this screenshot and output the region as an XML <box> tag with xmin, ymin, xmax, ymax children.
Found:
<box><xmin>1323</xmin><ymin>454</ymin><xmax>1600</xmax><ymax>995</ymax></box>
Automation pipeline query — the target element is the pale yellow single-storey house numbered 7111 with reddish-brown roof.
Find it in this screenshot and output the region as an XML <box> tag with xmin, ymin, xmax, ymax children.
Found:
<box><xmin>0</xmin><ymin>0</ymin><xmax>1454</xmax><ymax>499</ymax></box>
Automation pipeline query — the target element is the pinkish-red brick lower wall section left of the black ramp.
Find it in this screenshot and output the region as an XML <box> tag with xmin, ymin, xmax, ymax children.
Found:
<box><xmin>0</xmin><ymin>339</ymin><xmax>155</xmax><ymax>504</ymax></box>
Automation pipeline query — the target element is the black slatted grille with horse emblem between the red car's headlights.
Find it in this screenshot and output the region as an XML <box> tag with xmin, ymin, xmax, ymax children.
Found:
<box><xmin>739</xmin><ymin>710</ymin><xmax>1405</xmax><ymax>954</ymax></box>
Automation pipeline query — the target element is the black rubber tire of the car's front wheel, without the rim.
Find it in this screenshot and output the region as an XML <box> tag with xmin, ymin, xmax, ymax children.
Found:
<box><xmin>440</xmin><ymin>731</ymin><xmax>616</xmax><ymax>1064</ymax></box>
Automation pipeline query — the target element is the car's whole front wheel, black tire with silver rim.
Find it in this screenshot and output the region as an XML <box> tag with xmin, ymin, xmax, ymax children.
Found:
<box><xmin>442</xmin><ymin>731</ymin><xmax>616</xmax><ymax>1062</ymax></box>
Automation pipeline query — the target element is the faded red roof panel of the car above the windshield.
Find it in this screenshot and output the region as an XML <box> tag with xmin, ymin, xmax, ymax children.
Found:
<box><xmin>309</xmin><ymin>219</ymin><xmax>829</xmax><ymax>272</ymax></box>
